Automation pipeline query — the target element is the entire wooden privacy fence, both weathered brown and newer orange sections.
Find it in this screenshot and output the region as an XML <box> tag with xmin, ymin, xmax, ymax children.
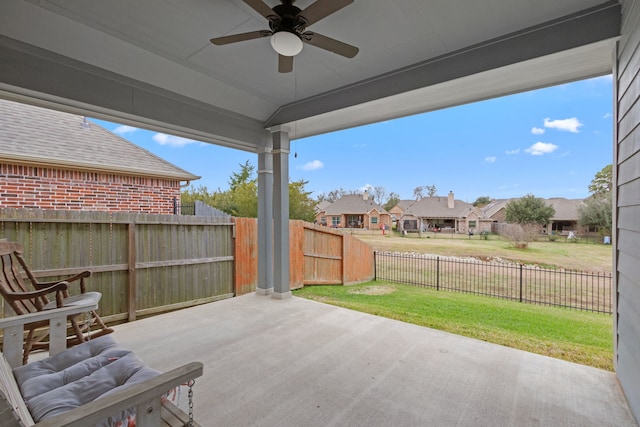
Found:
<box><xmin>0</xmin><ymin>208</ymin><xmax>374</xmax><ymax>322</ymax></box>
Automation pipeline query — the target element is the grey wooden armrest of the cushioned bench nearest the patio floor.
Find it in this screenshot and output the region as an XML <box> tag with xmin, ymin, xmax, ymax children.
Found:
<box><xmin>35</xmin><ymin>362</ymin><xmax>203</xmax><ymax>427</ymax></box>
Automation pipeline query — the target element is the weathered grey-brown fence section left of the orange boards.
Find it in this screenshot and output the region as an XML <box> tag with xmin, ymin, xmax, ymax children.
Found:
<box><xmin>0</xmin><ymin>209</ymin><xmax>234</xmax><ymax>322</ymax></box>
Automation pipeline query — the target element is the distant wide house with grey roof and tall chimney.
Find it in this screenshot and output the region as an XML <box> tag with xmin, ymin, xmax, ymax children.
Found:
<box><xmin>397</xmin><ymin>192</ymin><xmax>491</xmax><ymax>233</ymax></box>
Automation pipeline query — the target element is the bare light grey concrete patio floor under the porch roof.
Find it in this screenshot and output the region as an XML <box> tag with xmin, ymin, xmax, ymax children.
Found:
<box><xmin>113</xmin><ymin>294</ymin><xmax>636</xmax><ymax>427</ymax></box>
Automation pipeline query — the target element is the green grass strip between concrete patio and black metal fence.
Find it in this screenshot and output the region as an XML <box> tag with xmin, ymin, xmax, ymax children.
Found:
<box><xmin>294</xmin><ymin>282</ymin><xmax>613</xmax><ymax>371</ymax></box>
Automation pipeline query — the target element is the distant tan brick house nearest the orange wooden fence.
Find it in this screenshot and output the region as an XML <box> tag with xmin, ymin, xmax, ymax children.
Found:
<box><xmin>316</xmin><ymin>192</ymin><xmax>391</xmax><ymax>230</ymax></box>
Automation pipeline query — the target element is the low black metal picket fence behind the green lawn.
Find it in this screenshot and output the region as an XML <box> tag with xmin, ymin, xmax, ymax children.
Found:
<box><xmin>374</xmin><ymin>252</ymin><xmax>612</xmax><ymax>314</ymax></box>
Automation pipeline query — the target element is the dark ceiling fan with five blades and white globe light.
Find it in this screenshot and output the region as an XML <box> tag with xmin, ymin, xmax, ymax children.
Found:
<box><xmin>211</xmin><ymin>0</ymin><xmax>358</xmax><ymax>73</ymax></box>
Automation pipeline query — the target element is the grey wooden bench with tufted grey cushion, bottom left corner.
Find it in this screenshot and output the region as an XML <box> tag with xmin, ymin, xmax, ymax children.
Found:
<box><xmin>0</xmin><ymin>304</ymin><xmax>202</xmax><ymax>427</ymax></box>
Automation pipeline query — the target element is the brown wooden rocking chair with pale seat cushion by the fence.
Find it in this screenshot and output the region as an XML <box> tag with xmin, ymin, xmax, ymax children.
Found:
<box><xmin>0</xmin><ymin>240</ymin><xmax>113</xmax><ymax>364</ymax></box>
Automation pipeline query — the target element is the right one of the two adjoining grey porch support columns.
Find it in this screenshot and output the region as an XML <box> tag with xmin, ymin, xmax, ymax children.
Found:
<box><xmin>271</xmin><ymin>127</ymin><xmax>291</xmax><ymax>299</ymax></box>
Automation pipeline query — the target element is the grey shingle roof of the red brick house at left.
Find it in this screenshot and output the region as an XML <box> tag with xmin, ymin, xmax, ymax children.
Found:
<box><xmin>0</xmin><ymin>99</ymin><xmax>200</xmax><ymax>181</ymax></box>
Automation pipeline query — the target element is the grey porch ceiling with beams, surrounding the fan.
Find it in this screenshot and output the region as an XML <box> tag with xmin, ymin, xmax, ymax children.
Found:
<box><xmin>0</xmin><ymin>0</ymin><xmax>621</xmax><ymax>152</ymax></box>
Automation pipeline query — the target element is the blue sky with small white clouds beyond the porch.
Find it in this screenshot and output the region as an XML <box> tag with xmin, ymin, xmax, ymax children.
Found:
<box><xmin>96</xmin><ymin>76</ymin><xmax>613</xmax><ymax>203</ymax></box>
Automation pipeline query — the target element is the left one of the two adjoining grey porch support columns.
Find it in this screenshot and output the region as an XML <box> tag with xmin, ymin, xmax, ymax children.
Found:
<box><xmin>256</xmin><ymin>142</ymin><xmax>273</xmax><ymax>295</ymax></box>
